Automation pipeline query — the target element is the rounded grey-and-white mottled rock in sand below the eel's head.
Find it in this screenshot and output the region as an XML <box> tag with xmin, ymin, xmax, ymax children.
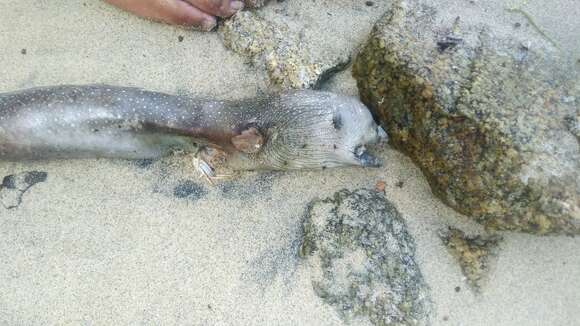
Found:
<box><xmin>300</xmin><ymin>189</ymin><xmax>429</xmax><ymax>325</ymax></box>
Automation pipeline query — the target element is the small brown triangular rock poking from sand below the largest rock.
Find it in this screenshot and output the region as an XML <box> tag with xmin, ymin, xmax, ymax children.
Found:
<box><xmin>439</xmin><ymin>227</ymin><xmax>503</xmax><ymax>292</ymax></box>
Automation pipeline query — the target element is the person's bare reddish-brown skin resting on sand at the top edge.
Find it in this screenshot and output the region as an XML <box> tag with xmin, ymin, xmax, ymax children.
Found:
<box><xmin>105</xmin><ymin>0</ymin><xmax>264</xmax><ymax>31</ymax></box>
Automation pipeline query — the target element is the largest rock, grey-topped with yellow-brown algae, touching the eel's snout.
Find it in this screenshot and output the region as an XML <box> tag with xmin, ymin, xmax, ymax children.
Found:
<box><xmin>353</xmin><ymin>1</ymin><xmax>580</xmax><ymax>234</ymax></box>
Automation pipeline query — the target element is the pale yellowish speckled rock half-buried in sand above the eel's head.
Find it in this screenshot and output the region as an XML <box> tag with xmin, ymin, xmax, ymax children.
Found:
<box><xmin>219</xmin><ymin>11</ymin><xmax>350</xmax><ymax>89</ymax></box>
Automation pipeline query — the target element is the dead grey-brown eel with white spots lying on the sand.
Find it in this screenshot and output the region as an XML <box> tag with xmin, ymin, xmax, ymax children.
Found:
<box><xmin>0</xmin><ymin>85</ymin><xmax>387</xmax><ymax>170</ymax></box>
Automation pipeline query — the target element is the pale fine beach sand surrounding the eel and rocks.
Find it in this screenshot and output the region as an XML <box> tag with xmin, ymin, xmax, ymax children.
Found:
<box><xmin>0</xmin><ymin>0</ymin><xmax>580</xmax><ymax>325</ymax></box>
